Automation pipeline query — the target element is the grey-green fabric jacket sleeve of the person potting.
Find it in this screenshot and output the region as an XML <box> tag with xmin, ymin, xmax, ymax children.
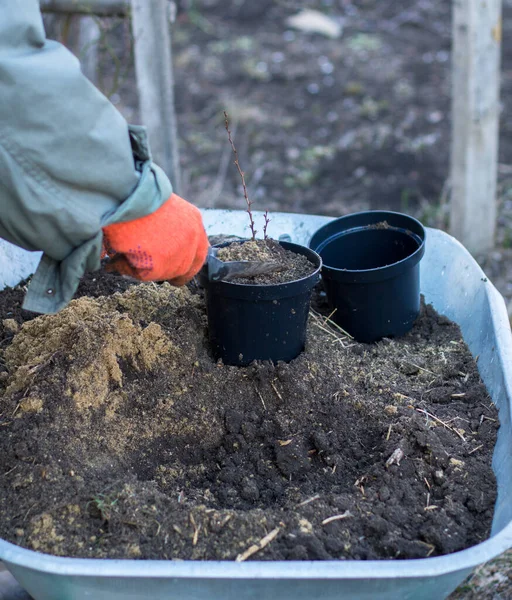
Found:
<box><xmin>0</xmin><ymin>0</ymin><xmax>172</xmax><ymax>313</ymax></box>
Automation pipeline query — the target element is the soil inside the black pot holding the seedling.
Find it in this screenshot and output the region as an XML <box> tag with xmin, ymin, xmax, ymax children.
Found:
<box><xmin>213</xmin><ymin>239</ymin><xmax>317</xmax><ymax>285</ymax></box>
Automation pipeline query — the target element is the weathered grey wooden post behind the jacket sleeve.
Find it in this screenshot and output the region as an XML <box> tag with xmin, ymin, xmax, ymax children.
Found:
<box><xmin>131</xmin><ymin>0</ymin><xmax>181</xmax><ymax>192</ymax></box>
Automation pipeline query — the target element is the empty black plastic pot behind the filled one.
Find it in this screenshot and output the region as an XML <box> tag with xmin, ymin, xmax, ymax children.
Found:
<box><xmin>309</xmin><ymin>210</ymin><xmax>425</xmax><ymax>342</ymax></box>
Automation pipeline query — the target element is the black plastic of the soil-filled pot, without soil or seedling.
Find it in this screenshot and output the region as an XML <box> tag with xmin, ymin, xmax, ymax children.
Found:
<box><xmin>199</xmin><ymin>242</ymin><xmax>322</xmax><ymax>366</ymax></box>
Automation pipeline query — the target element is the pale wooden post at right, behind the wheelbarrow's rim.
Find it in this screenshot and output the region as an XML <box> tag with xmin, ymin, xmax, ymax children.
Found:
<box><xmin>450</xmin><ymin>0</ymin><xmax>501</xmax><ymax>254</ymax></box>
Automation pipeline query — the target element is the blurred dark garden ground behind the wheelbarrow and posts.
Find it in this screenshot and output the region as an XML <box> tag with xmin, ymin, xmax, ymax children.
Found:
<box><xmin>12</xmin><ymin>0</ymin><xmax>512</xmax><ymax>600</ymax></box>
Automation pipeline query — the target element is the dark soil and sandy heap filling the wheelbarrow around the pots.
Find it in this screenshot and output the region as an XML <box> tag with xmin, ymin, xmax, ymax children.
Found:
<box><xmin>0</xmin><ymin>274</ymin><xmax>498</xmax><ymax>560</ymax></box>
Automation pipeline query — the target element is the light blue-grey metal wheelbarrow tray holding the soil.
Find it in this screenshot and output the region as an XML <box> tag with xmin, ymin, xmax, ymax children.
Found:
<box><xmin>0</xmin><ymin>210</ymin><xmax>512</xmax><ymax>600</ymax></box>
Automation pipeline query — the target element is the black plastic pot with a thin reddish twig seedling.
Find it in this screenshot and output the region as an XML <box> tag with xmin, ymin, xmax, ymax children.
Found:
<box><xmin>200</xmin><ymin>113</ymin><xmax>322</xmax><ymax>366</ymax></box>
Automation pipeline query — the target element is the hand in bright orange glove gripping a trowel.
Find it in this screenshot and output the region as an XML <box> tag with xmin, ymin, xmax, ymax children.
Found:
<box><xmin>103</xmin><ymin>194</ymin><xmax>209</xmax><ymax>285</ymax></box>
